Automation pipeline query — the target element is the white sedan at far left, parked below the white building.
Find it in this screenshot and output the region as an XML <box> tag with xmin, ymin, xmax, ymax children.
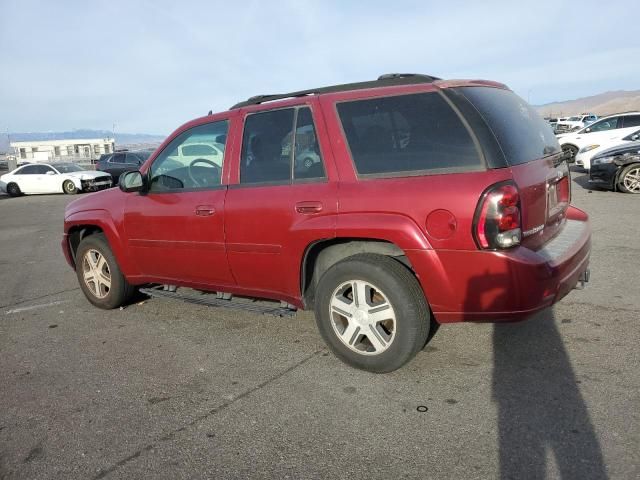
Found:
<box><xmin>0</xmin><ymin>163</ymin><xmax>113</xmax><ymax>197</ymax></box>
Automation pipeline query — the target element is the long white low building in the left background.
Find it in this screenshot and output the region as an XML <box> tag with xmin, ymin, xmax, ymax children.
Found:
<box><xmin>10</xmin><ymin>138</ymin><xmax>115</xmax><ymax>162</ymax></box>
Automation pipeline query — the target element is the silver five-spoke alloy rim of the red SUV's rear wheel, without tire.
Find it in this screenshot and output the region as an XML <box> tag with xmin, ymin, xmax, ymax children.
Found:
<box><xmin>330</xmin><ymin>280</ymin><xmax>396</xmax><ymax>355</ymax></box>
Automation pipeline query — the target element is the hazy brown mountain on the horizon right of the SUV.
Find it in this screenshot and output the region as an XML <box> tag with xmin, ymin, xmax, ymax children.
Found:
<box><xmin>535</xmin><ymin>90</ymin><xmax>640</xmax><ymax>117</ymax></box>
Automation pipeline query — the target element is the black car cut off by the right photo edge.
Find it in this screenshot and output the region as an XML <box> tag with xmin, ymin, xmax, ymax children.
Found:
<box><xmin>589</xmin><ymin>142</ymin><xmax>640</xmax><ymax>193</ymax></box>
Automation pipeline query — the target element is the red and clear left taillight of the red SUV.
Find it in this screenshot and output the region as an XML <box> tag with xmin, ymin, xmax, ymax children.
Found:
<box><xmin>473</xmin><ymin>182</ymin><xmax>522</xmax><ymax>249</ymax></box>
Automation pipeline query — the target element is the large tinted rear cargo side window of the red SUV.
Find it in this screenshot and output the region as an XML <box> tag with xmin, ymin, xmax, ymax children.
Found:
<box><xmin>337</xmin><ymin>93</ymin><xmax>483</xmax><ymax>175</ymax></box>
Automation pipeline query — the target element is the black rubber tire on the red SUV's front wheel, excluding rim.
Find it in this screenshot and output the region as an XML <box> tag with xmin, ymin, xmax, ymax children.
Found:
<box><xmin>76</xmin><ymin>233</ymin><xmax>135</xmax><ymax>310</ymax></box>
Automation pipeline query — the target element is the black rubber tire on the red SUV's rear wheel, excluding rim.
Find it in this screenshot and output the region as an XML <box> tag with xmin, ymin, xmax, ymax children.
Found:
<box><xmin>315</xmin><ymin>253</ymin><xmax>431</xmax><ymax>373</ymax></box>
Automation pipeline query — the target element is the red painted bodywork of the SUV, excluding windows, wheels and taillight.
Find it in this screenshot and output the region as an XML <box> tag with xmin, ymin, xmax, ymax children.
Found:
<box><xmin>62</xmin><ymin>80</ymin><xmax>590</xmax><ymax>323</ymax></box>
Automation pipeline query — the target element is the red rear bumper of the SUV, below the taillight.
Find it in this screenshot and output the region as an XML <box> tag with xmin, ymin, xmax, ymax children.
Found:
<box><xmin>407</xmin><ymin>207</ymin><xmax>591</xmax><ymax>323</ymax></box>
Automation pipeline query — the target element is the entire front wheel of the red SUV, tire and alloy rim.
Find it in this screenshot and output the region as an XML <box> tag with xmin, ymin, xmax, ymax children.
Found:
<box><xmin>76</xmin><ymin>234</ymin><xmax>134</xmax><ymax>310</ymax></box>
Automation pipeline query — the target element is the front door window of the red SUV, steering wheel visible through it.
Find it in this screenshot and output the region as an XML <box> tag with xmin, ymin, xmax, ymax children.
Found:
<box><xmin>149</xmin><ymin>120</ymin><xmax>229</xmax><ymax>192</ymax></box>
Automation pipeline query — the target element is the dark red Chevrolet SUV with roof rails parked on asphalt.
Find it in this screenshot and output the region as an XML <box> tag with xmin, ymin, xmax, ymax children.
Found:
<box><xmin>62</xmin><ymin>74</ymin><xmax>591</xmax><ymax>372</ymax></box>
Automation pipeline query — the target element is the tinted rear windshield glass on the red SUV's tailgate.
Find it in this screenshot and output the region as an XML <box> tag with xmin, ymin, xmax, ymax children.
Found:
<box><xmin>456</xmin><ymin>87</ymin><xmax>560</xmax><ymax>165</ymax></box>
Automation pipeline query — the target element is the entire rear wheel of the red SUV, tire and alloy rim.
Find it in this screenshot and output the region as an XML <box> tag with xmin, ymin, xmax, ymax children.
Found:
<box><xmin>315</xmin><ymin>253</ymin><xmax>430</xmax><ymax>373</ymax></box>
